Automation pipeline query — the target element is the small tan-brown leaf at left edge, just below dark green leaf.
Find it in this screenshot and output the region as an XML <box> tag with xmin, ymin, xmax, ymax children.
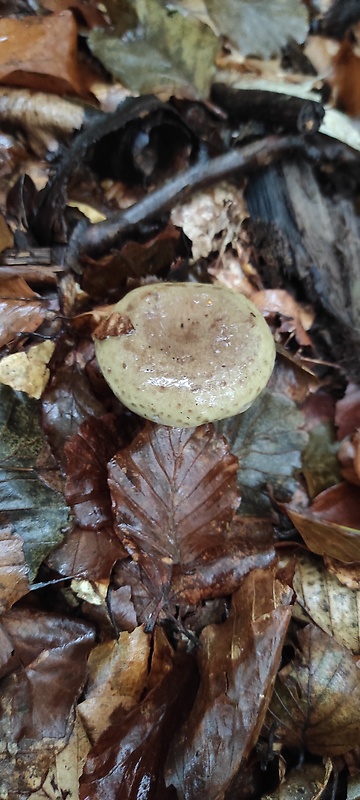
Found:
<box><xmin>0</xmin><ymin>525</ymin><xmax>30</xmax><ymax>613</ymax></box>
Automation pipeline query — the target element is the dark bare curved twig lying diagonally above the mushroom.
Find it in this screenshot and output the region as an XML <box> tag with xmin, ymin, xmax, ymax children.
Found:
<box><xmin>71</xmin><ymin>136</ymin><xmax>318</xmax><ymax>255</ymax></box>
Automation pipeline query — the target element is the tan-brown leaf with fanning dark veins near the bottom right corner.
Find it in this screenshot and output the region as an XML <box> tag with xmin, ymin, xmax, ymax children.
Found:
<box><xmin>267</xmin><ymin>625</ymin><xmax>360</xmax><ymax>756</ymax></box>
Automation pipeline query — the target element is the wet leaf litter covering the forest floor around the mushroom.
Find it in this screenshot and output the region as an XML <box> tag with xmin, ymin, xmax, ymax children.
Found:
<box><xmin>0</xmin><ymin>0</ymin><xmax>360</xmax><ymax>800</ymax></box>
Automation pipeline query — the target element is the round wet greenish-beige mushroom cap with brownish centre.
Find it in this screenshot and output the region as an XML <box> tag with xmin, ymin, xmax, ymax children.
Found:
<box><xmin>94</xmin><ymin>283</ymin><xmax>275</xmax><ymax>428</ymax></box>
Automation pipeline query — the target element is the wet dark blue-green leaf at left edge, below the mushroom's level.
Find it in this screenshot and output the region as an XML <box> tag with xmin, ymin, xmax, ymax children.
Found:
<box><xmin>0</xmin><ymin>386</ymin><xmax>69</xmax><ymax>579</ymax></box>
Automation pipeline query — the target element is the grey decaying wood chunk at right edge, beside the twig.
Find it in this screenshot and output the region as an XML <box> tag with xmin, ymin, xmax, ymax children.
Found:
<box><xmin>247</xmin><ymin>159</ymin><xmax>360</xmax><ymax>379</ymax></box>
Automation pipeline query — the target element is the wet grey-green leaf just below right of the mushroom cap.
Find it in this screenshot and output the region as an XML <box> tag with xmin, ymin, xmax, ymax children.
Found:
<box><xmin>216</xmin><ymin>390</ymin><xmax>308</xmax><ymax>515</ymax></box>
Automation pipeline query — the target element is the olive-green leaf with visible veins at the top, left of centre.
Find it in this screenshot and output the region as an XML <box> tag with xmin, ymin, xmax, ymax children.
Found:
<box><xmin>88</xmin><ymin>0</ymin><xmax>219</xmax><ymax>97</ymax></box>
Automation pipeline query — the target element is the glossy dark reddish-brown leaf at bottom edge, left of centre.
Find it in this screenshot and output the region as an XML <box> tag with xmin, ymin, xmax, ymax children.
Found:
<box><xmin>80</xmin><ymin>655</ymin><xmax>196</xmax><ymax>800</ymax></box>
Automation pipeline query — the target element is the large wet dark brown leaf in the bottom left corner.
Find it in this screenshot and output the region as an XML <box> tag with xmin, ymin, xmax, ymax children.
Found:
<box><xmin>0</xmin><ymin>609</ymin><xmax>94</xmax><ymax>798</ymax></box>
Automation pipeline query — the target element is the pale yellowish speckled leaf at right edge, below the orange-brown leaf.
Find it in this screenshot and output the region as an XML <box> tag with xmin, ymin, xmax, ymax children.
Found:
<box><xmin>293</xmin><ymin>553</ymin><xmax>360</xmax><ymax>653</ymax></box>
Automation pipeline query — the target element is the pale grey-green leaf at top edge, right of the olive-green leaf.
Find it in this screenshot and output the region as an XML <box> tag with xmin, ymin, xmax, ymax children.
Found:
<box><xmin>205</xmin><ymin>0</ymin><xmax>308</xmax><ymax>58</ymax></box>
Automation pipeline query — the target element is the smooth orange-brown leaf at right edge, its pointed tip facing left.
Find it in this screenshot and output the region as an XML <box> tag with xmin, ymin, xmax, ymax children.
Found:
<box><xmin>284</xmin><ymin>483</ymin><xmax>360</xmax><ymax>562</ymax></box>
